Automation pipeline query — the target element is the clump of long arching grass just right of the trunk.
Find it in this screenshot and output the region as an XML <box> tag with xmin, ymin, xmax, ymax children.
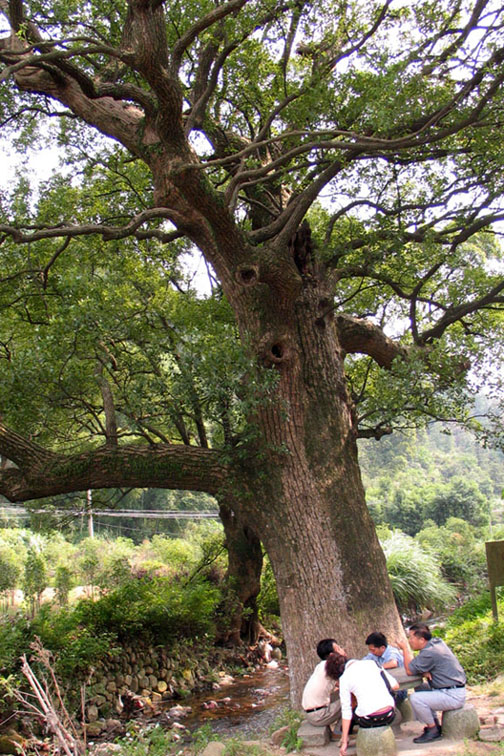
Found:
<box><xmin>381</xmin><ymin>530</ymin><xmax>456</xmax><ymax>615</ymax></box>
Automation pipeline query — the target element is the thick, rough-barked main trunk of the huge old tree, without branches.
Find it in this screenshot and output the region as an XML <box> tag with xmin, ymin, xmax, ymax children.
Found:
<box><xmin>229</xmin><ymin>281</ymin><xmax>402</xmax><ymax>706</ymax></box>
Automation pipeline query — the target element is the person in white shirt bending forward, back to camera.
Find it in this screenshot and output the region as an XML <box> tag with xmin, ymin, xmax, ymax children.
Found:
<box><xmin>326</xmin><ymin>653</ymin><xmax>399</xmax><ymax>756</ymax></box>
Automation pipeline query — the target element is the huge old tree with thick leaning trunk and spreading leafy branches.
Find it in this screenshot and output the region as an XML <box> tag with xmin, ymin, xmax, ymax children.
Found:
<box><xmin>0</xmin><ymin>0</ymin><xmax>504</xmax><ymax>703</ymax></box>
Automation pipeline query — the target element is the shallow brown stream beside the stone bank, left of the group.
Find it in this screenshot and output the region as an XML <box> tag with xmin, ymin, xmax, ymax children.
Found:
<box><xmin>161</xmin><ymin>663</ymin><xmax>289</xmax><ymax>739</ymax></box>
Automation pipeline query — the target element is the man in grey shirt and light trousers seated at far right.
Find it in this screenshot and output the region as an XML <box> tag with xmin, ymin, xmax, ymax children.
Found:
<box><xmin>398</xmin><ymin>623</ymin><xmax>466</xmax><ymax>743</ymax></box>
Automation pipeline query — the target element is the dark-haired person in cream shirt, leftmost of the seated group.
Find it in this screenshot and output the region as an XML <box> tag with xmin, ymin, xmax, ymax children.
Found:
<box><xmin>301</xmin><ymin>638</ymin><xmax>343</xmax><ymax>727</ymax></box>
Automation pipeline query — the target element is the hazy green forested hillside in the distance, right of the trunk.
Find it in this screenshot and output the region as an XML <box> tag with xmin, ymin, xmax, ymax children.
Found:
<box><xmin>359</xmin><ymin>423</ymin><xmax>504</xmax><ymax>535</ymax></box>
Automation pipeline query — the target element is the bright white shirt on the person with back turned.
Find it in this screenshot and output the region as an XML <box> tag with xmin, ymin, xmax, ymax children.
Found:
<box><xmin>340</xmin><ymin>659</ymin><xmax>396</xmax><ymax>719</ymax></box>
